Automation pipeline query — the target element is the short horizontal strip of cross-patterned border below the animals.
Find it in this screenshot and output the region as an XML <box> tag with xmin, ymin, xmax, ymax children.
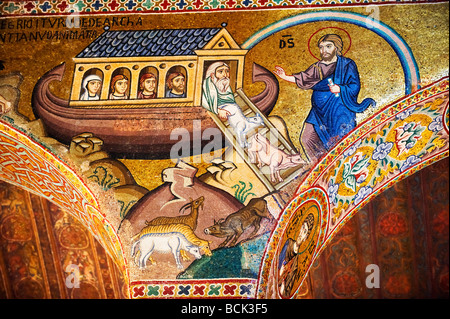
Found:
<box><xmin>130</xmin><ymin>278</ymin><xmax>256</xmax><ymax>299</ymax></box>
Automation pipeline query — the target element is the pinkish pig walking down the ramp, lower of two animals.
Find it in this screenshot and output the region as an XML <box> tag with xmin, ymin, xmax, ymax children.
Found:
<box><xmin>248</xmin><ymin>133</ymin><xmax>307</xmax><ymax>183</ymax></box>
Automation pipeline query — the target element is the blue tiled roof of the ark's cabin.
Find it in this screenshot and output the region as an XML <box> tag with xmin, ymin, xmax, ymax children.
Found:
<box><xmin>77</xmin><ymin>28</ymin><xmax>221</xmax><ymax>58</ymax></box>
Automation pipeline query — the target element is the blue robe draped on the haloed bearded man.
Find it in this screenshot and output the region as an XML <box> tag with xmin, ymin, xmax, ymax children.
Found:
<box><xmin>306</xmin><ymin>56</ymin><xmax>375</xmax><ymax>150</ymax></box>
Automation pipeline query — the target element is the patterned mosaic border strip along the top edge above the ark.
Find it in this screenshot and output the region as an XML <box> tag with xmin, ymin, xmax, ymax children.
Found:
<box><xmin>0</xmin><ymin>0</ymin><xmax>447</xmax><ymax>17</ymax></box>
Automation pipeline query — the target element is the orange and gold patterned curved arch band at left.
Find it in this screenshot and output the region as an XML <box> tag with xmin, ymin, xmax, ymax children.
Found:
<box><xmin>0</xmin><ymin>120</ymin><xmax>129</xmax><ymax>298</ymax></box>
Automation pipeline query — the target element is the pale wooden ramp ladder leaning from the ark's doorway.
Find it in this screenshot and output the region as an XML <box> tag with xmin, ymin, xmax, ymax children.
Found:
<box><xmin>208</xmin><ymin>88</ymin><xmax>303</xmax><ymax>192</ymax></box>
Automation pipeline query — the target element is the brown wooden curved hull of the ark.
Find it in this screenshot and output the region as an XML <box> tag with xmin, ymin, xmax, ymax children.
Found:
<box><xmin>32</xmin><ymin>63</ymin><xmax>279</xmax><ymax>159</ymax></box>
